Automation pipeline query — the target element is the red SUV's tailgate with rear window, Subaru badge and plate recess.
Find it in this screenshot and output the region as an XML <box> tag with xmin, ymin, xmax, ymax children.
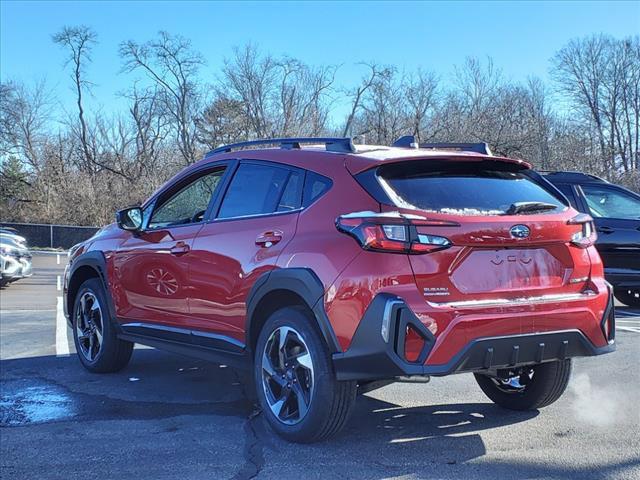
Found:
<box><xmin>378</xmin><ymin>160</ymin><xmax>590</xmax><ymax>306</ymax></box>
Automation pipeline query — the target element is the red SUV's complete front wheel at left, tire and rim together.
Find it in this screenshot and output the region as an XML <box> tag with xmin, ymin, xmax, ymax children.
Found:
<box><xmin>73</xmin><ymin>278</ymin><xmax>133</xmax><ymax>373</ymax></box>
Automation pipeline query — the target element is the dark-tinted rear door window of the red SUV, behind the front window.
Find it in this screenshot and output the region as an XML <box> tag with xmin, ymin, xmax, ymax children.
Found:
<box><xmin>218</xmin><ymin>163</ymin><xmax>290</xmax><ymax>218</ymax></box>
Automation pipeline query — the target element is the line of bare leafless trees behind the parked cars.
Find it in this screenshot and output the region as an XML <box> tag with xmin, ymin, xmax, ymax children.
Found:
<box><xmin>0</xmin><ymin>31</ymin><xmax>640</xmax><ymax>229</ymax></box>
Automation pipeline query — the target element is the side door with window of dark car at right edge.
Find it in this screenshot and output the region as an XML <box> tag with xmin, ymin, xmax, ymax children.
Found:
<box><xmin>579</xmin><ymin>184</ymin><xmax>640</xmax><ymax>271</ymax></box>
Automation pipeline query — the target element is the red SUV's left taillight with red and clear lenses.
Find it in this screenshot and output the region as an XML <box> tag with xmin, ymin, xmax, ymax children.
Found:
<box><xmin>336</xmin><ymin>212</ymin><xmax>451</xmax><ymax>254</ymax></box>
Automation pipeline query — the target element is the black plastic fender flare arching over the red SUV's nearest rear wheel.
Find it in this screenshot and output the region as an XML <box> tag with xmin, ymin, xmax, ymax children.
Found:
<box><xmin>245</xmin><ymin>267</ymin><xmax>342</xmax><ymax>354</ymax></box>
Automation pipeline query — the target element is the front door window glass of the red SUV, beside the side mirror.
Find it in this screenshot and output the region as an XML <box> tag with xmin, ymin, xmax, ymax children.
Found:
<box><xmin>148</xmin><ymin>169</ymin><xmax>224</xmax><ymax>228</ymax></box>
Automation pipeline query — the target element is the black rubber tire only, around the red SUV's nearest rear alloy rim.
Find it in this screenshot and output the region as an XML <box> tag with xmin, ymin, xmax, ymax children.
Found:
<box><xmin>254</xmin><ymin>307</ymin><xmax>357</xmax><ymax>443</ymax></box>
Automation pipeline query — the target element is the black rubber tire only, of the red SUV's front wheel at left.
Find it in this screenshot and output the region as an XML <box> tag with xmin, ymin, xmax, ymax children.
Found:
<box><xmin>72</xmin><ymin>278</ymin><xmax>133</xmax><ymax>373</ymax></box>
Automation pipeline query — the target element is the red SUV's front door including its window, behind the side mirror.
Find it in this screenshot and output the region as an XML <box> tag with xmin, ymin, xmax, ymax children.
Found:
<box><xmin>113</xmin><ymin>167</ymin><xmax>224</xmax><ymax>327</ymax></box>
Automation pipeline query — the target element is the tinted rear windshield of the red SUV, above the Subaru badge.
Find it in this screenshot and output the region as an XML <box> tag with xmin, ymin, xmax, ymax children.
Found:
<box><xmin>377</xmin><ymin>160</ymin><xmax>565</xmax><ymax>215</ymax></box>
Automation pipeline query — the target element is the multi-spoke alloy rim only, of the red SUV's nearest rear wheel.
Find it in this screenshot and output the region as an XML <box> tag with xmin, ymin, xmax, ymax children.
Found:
<box><xmin>261</xmin><ymin>326</ymin><xmax>315</xmax><ymax>425</ymax></box>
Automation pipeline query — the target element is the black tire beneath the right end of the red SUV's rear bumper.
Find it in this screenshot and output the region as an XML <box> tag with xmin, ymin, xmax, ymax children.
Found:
<box><xmin>475</xmin><ymin>359</ymin><xmax>571</xmax><ymax>410</ymax></box>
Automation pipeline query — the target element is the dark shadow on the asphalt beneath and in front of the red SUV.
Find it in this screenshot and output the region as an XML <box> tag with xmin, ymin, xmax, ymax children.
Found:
<box><xmin>0</xmin><ymin>349</ymin><xmax>638</xmax><ymax>479</ymax></box>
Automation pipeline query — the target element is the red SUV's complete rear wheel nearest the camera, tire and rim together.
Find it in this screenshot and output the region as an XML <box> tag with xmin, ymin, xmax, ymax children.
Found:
<box><xmin>254</xmin><ymin>307</ymin><xmax>357</xmax><ymax>443</ymax></box>
